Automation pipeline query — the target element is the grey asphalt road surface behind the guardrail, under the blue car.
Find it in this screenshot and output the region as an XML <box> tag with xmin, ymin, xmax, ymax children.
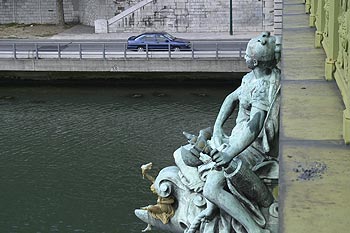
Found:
<box><xmin>0</xmin><ymin>39</ymin><xmax>248</xmax><ymax>59</ymax></box>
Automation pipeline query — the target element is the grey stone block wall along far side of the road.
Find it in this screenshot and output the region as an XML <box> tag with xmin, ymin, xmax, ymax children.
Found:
<box><xmin>0</xmin><ymin>0</ymin><xmax>274</xmax><ymax>32</ymax></box>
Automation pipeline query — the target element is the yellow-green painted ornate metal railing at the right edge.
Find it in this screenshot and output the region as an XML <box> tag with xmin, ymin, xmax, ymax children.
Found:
<box><xmin>304</xmin><ymin>0</ymin><xmax>350</xmax><ymax>144</ymax></box>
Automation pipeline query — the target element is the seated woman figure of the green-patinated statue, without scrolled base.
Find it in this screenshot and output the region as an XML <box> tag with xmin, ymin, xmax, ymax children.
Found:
<box><xmin>197</xmin><ymin>32</ymin><xmax>280</xmax><ymax>233</ymax></box>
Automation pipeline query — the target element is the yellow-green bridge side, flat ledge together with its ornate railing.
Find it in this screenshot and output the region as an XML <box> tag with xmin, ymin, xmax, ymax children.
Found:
<box><xmin>279</xmin><ymin>0</ymin><xmax>350</xmax><ymax>233</ymax></box>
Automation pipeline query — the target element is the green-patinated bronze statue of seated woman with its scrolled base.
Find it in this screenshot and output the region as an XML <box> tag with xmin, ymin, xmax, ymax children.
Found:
<box><xmin>135</xmin><ymin>32</ymin><xmax>281</xmax><ymax>233</ymax></box>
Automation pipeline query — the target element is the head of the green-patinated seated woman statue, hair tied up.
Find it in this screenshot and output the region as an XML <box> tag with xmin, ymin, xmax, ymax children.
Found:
<box><xmin>245</xmin><ymin>32</ymin><xmax>281</xmax><ymax>69</ymax></box>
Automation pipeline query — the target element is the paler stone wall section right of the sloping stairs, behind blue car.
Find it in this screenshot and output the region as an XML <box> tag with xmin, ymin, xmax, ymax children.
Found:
<box><xmin>109</xmin><ymin>0</ymin><xmax>274</xmax><ymax>32</ymax></box>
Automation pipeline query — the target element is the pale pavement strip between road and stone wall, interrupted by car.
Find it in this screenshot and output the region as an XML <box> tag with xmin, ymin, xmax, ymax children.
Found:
<box><xmin>50</xmin><ymin>25</ymin><xmax>261</xmax><ymax>40</ymax></box>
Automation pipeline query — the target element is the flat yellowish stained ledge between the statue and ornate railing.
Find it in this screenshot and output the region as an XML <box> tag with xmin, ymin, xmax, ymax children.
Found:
<box><xmin>279</xmin><ymin>0</ymin><xmax>350</xmax><ymax>233</ymax></box>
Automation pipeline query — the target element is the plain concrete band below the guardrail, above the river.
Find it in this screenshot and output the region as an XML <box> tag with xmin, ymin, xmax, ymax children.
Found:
<box><xmin>0</xmin><ymin>58</ymin><xmax>248</xmax><ymax>72</ymax></box>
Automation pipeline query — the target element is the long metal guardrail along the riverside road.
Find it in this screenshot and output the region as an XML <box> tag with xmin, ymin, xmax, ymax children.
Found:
<box><xmin>0</xmin><ymin>41</ymin><xmax>247</xmax><ymax>60</ymax></box>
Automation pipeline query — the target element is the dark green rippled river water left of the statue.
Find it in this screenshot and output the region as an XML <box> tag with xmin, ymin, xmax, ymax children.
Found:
<box><xmin>0</xmin><ymin>86</ymin><xmax>235</xmax><ymax>233</ymax></box>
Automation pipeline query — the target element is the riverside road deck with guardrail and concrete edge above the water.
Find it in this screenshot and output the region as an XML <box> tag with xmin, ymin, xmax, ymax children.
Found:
<box><xmin>0</xmin><ymin>41</ymin><xmax>247</xmax><ymax>78</ymax></box>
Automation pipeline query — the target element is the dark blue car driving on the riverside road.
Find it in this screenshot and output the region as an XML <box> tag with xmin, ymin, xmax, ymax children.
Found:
<box><xmin>127</xmin><ymin>32</ymin><xmax>191</xmax><ymax>52</ymax></box>
